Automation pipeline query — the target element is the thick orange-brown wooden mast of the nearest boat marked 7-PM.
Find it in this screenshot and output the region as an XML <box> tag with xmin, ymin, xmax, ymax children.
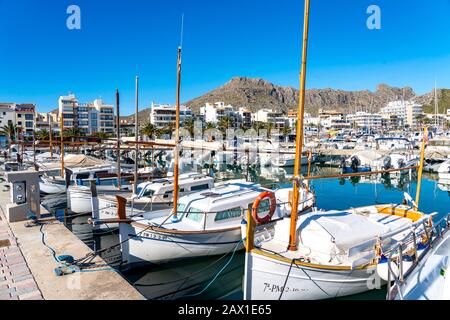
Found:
<box><xmin>289</xmin><ymin>0</ymin><xmax>309</xmax><ymax>251</ymax></box>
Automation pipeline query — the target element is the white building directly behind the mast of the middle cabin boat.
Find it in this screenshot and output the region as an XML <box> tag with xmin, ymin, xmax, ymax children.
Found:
<box><xmin>150</xmin><ymin>102</ymin><xmax>192</xmax><ymax>129</ymax></box>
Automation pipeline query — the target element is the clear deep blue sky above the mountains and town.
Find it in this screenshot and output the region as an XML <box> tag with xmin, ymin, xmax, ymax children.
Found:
<box><xmin>0</xmin><ymin>0</ymin><xmax>450</xmax><ymax>114</ymax></box>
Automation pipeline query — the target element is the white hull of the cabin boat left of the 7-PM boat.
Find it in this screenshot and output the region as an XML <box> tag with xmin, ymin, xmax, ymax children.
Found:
<box><xmin>119</xmin><ymin>223</ymin><xmax>244</xmax><ymax>265</ymax></box>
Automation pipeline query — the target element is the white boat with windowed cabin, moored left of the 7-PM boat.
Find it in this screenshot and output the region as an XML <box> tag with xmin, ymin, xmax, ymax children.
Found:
<box><xmin>119</xmin><ymin>181</ymin><xmax>315</xmax><ymax>265</ymax></box>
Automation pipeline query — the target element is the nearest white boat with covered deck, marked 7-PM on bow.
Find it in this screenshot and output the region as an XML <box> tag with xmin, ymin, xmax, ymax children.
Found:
<box><xmin>244</xmin><ymin>204</ymin><xmax>428</xmax><ymax>300</ymax></box>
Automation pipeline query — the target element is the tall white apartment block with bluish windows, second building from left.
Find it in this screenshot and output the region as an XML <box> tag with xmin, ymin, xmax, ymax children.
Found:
<box><xmin>58</xmin><ymin>94</ymin><xmax>114</xmax><ymax>134</ymax></box>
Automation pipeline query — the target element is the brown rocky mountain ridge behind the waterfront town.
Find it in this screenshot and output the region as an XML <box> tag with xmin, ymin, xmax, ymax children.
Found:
<box><xmin>124</xmin><ymin>77</ymin><xmax>450</xmax><ymax>122</ymax></box>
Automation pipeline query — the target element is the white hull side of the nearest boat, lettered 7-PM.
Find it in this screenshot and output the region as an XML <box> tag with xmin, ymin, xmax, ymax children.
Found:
<box><xmin>244</xmin><ymin>253</ymin><xmax>381</xmax><ymax>300</ymax></box>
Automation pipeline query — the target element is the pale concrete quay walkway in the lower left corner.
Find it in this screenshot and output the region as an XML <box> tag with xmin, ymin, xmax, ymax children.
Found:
<box><xmin>0</xmin><ymin>181</ymin><xmax>145</xmax><ymax>300</ymax></box>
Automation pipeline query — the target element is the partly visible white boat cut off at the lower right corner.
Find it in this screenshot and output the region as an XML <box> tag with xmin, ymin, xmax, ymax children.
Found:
<box><xmin>387</xmin><ymin>216</ymin><xmax>450</xmax><ymax>300</ymax></box>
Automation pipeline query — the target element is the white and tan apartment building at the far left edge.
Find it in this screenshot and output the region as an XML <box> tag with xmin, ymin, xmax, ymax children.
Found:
<box><xmin>0</xmin><ymin>103</ymin><xmax>36</xmax><ymax>136</ymax></box>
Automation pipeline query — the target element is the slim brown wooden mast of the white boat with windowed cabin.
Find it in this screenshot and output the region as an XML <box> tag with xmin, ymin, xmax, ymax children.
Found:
<box><xmin>172</xmin><ymin>46</ymin><xmax>181</xmax><ymax>220</ymax></box>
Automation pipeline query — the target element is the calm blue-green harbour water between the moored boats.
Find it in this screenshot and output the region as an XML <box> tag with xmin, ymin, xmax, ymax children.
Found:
<box><xmin>46</xmin><ymin>167</ymin><xmax>450</xmax><ymax>299</ymax></box>
